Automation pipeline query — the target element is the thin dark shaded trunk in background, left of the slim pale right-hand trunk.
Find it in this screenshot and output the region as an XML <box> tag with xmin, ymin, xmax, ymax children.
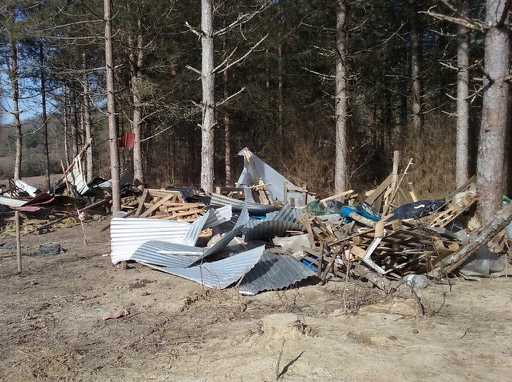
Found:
<box><xmin>409</xmin><ymin>0</ymin><xmax>423</xmax><ymax>134</ymax></box>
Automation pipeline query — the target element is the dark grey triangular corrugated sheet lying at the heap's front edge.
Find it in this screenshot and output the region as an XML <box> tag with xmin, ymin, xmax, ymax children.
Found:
<box><xmin>239</xmin><ymin>251</ymin><xmax>315</xmax><ymax>296</ymax></box>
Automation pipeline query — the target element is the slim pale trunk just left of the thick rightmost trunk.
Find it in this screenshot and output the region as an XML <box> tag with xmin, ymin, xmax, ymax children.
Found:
<box><xmin>455</xmin><ymin>21</ymin><xmax>469</xmax><ymax>187</ymax></box>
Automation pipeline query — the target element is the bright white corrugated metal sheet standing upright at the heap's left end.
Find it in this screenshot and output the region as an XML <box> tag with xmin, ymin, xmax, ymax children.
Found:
<box><xmin>110</xmin><ymin>218</ymin><xmax>206</xmax><ymax>264</ymax></box>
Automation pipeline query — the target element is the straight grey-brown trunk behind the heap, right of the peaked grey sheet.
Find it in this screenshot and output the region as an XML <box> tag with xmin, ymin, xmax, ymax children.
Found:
<box><xmin>334</xmin><ymin>0</ymin><xmax>348</xmax><ymax>193</ymax></box>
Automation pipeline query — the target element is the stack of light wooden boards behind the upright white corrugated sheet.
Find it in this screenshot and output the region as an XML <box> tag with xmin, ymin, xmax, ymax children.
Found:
<box><xmin>135</xmin><ymin>189</ymin><xmax>205</xmax><ymax>222</ymax></box>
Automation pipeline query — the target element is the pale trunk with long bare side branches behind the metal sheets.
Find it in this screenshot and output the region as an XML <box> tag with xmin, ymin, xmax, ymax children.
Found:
<box><xmin>201</xmin><ymin>0</ymin><xmax>215</xmax><ymax>194</ymax></box>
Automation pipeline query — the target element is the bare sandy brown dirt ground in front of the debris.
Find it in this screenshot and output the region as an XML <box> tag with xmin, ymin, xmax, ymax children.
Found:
<box><xmin>0</xmin><ymin>221</ymin><xmax>512</xmax><ymax>382</ymax></box>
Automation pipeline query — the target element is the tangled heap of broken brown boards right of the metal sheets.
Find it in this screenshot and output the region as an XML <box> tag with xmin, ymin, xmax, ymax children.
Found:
<box><xmin>304</xmin><ymin>217</ymin><xmax>459</xmax><ymax>288</ymax></box>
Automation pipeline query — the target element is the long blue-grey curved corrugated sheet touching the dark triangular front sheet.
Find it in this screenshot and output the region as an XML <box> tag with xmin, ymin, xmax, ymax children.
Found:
<box><xmin>142</xmin><ymin>246</ymin><xmax>265</xmax><ymax>289</ymax></box>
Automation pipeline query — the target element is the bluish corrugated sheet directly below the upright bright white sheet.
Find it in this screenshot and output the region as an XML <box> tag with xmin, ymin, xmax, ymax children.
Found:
<box><xmin>132</xmin><ymin>241</ymin><xmax>203</xmax><ymax>268</ymax></box>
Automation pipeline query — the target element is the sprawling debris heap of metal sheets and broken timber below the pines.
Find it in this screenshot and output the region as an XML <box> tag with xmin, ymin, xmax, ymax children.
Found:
<box><xmin>0</xmin><ymin>148</ymin><xmax>512</xmax><ymax>295</ymax></box>
